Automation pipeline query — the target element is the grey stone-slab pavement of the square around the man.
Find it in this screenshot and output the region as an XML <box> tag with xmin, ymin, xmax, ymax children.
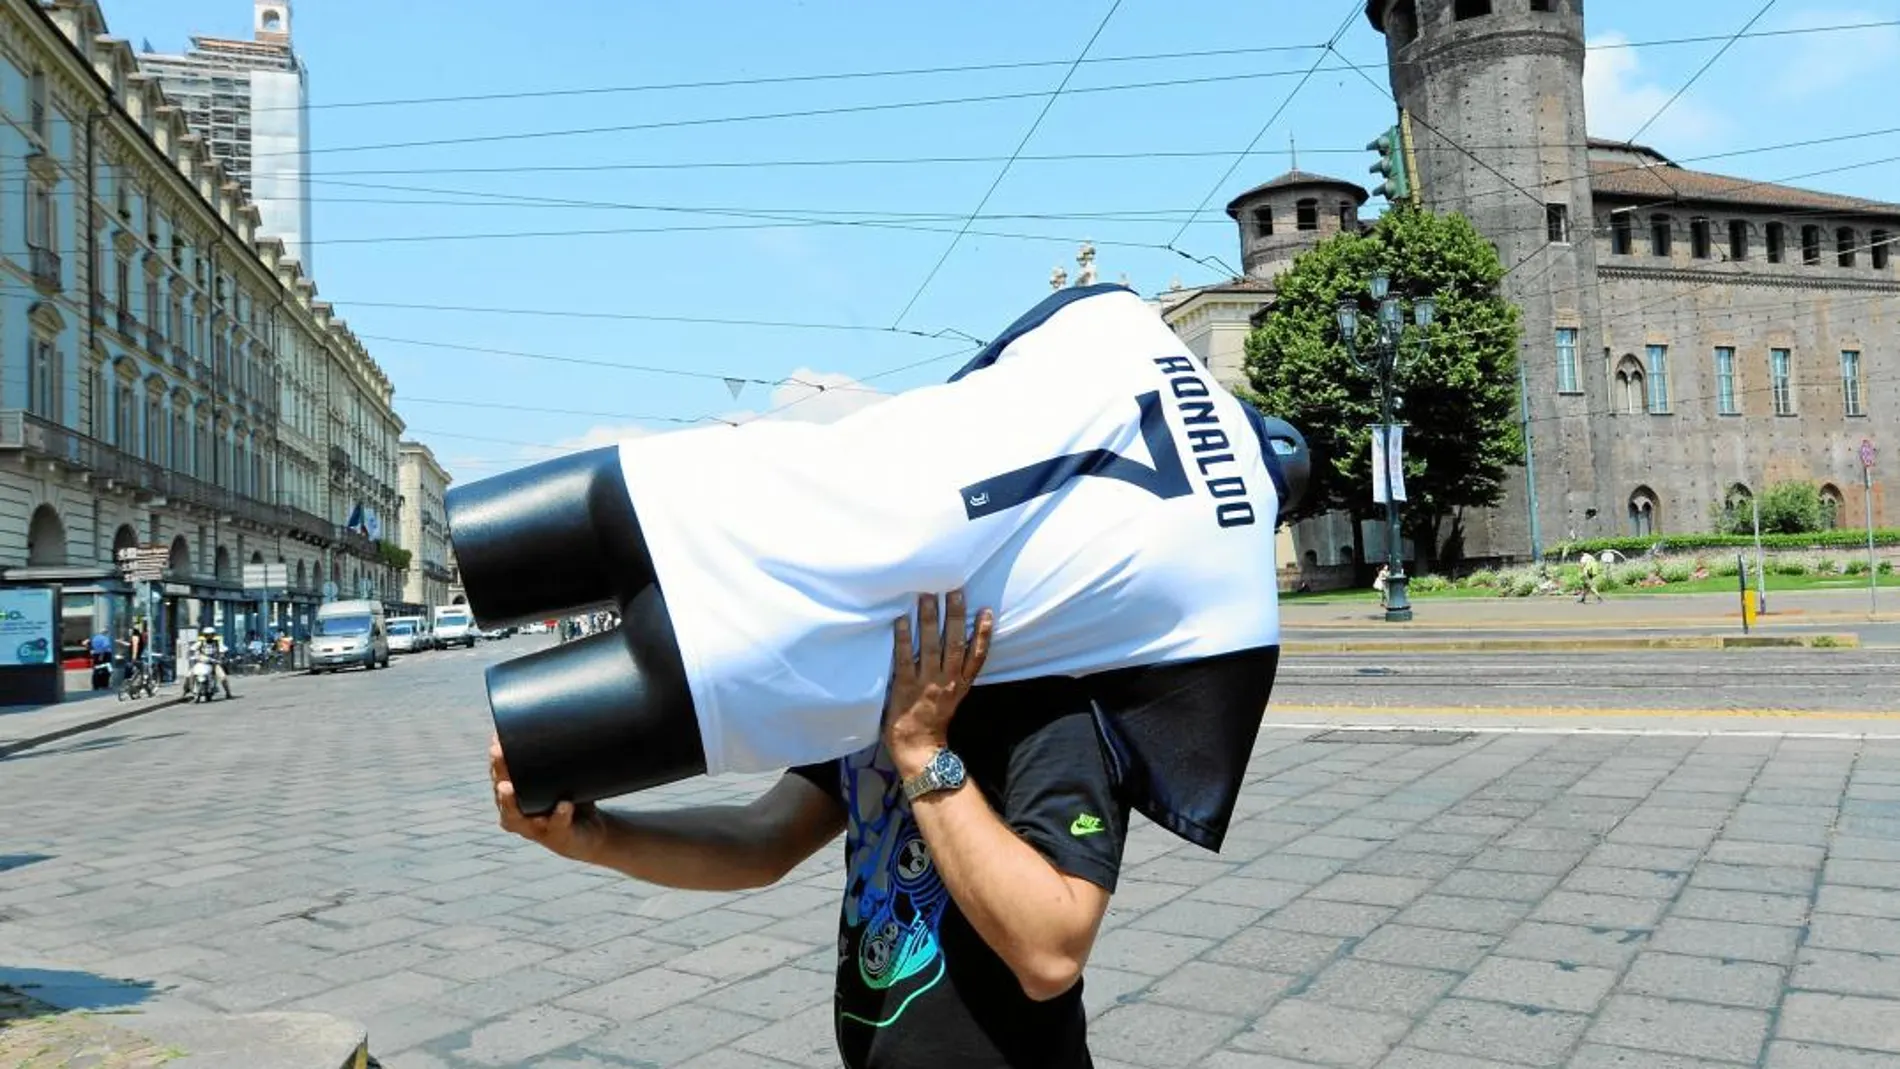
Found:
<box><xmin>0</xmin><ymin>638</ymin><xmax>1900</xmax><ymax>1069</ymax></box>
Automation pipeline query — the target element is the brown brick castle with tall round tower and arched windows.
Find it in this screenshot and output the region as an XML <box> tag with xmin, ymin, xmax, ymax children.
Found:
<box><xmin>1366</xmin><ymin>0</ymin><xmax>1900</xmax><ymax>558</ymax></box>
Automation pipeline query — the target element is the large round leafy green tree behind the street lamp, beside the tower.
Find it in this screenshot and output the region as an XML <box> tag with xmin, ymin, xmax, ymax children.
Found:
<box><xmin>1245</xmin><ymin>205</ymin><xmax>1524</xmax><ymax>560</ymax></box>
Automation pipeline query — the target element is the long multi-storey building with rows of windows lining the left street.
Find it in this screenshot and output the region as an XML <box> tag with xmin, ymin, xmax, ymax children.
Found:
<box><xmin>0</xmin><ymin>0</ymin><xmax>401</xmax><ymax>664</ymax></box>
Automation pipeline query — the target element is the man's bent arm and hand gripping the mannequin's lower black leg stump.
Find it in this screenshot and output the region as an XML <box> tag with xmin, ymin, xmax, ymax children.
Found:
<box><xmin>488</xmin><ymin>741</ymin><xmax>844</xmax><ymax>891</ymax></box>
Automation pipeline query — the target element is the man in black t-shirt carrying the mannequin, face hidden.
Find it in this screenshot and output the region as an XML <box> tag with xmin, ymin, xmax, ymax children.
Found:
<box><xmin>488</xmin><ymin>592</ymin><xmax>1129</xmax><ymax>1069</ymax></box>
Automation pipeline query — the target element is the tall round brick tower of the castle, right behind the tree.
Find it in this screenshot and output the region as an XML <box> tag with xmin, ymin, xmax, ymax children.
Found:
<box><xmin>1366</xmin><ymin>0</ymin><xmax>1609</xmax><ymax>556</ymax></box>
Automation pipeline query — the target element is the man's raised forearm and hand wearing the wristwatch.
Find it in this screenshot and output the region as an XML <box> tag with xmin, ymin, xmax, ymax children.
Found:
<box><xmin>885</xmin><ymin>591</ymin><xmax>1110</xmax><ymax>1001</ymax></box>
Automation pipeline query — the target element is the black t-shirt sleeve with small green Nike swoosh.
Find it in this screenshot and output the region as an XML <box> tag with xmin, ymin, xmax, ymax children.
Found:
<box><xmin>999</xmin><ymin>708</ymin><xmax>1129</xmax><ymax>892</ymax></box>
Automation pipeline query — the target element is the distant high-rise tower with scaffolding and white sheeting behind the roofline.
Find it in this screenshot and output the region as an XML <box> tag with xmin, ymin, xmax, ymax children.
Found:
<box><xmin>139</xmin><ymin>0</ymin><xmax>305</xmax><ymax>273</ymax></box>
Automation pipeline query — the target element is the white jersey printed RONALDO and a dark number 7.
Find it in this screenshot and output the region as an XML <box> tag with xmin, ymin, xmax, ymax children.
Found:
<box><xmin>619</xmin><ymin>287</ymin><xmax>1279</xmax><ymax>775</ymax></box>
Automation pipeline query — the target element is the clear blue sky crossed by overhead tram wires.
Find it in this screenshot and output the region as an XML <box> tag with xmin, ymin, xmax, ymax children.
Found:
<box><xmin>105</xmin><ymin>0</ymin><xmax>1900</xmax><ymax>480</ymax></box>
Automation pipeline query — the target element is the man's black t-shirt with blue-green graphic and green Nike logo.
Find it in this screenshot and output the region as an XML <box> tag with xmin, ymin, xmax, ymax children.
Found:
<box><xmin>792</xmin><ymin>685</ymin><xmax>1129</xmax><ymax>1069</ymax></box>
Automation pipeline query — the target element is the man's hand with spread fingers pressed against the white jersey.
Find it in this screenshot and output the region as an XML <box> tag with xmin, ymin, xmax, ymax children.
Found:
<box><xmin>884</xmin><ymin>591</ymin><xmax>994</xmax><ymax>778</ymax></box>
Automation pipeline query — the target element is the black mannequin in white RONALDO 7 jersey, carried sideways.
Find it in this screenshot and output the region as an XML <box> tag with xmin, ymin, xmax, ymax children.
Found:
<box><xmin>447</xmin><ymin>285</ymin><xmax>1309</xmax><ymax>849</ymax></box>
